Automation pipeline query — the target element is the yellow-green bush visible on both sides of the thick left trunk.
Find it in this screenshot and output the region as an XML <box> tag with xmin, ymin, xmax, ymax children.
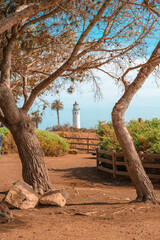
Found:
<box><xmin>0</xmin><ymin>128</ymin><xmax>69</xmax><ymax>156</ymax></box>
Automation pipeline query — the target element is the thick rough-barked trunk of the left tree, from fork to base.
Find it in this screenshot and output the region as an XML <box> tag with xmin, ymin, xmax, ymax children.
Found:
<box><xmin>10</xmin><ymin>117</ymin><xmax>51</xmax><ymax>194</ymax></box>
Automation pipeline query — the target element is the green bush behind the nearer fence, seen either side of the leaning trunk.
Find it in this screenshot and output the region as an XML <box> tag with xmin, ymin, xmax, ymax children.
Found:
<box><xmin>97</xmin><ymin>118</ymin><xmax>160</xmax><ymax>154</ymax></box>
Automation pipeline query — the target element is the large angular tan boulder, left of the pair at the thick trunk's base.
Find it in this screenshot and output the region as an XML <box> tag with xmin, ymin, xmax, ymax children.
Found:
<box><xmin>5</xmin><ymin>181</ymin><xmax>39</xmax><ymax>209</ymax></box>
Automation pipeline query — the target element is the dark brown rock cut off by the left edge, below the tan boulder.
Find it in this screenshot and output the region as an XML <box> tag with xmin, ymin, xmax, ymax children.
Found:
<box><xmin>0</xmin><ymin>202</ymin><xmax>13</xmax><ymax>223</ymax></box>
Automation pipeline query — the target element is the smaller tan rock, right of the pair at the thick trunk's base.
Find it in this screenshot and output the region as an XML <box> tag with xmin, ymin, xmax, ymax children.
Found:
<box><xmin>39</xmin><ymin>189</ymin><xmax>68</xmax><ymax>207</ymax></box>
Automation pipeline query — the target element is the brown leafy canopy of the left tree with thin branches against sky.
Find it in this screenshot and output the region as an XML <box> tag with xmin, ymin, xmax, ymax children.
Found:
<box><xmin>0</xmin><ymin>0</ymin><xmax>158</xmax><ymax>109</ymax></box>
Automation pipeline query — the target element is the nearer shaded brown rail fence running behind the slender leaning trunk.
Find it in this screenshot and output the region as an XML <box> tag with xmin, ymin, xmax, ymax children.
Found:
<box><xmin>96</xmin><ymin>148</ymin><xmax>160</xmax><ymax>179</ymax></box>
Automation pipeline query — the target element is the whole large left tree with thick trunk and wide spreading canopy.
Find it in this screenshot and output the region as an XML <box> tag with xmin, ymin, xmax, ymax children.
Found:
<box><xmin>0</xmin><ymin>0</ymin><xmax>157</xmax><ymax>193</ymax></box>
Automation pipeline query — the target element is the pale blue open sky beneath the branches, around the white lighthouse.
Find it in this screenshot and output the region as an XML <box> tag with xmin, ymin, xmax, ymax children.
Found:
<box><xmin>39</xmin><ymin>70</ymin><xmax>160</xmax><ymax>130</ymax></box>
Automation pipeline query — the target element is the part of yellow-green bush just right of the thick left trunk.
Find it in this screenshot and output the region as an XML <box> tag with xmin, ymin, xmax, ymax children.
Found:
<box><xmin>36</xmin><ymin>129</ymin><xmax>69</xmax><ymax>156</ymax></box>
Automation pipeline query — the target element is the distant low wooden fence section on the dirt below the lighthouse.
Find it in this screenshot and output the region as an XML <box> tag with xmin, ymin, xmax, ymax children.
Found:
<box><xmin>64</xmin><ymin>137</ymin><xmax>99</xmax><ymax>152</ymax></box>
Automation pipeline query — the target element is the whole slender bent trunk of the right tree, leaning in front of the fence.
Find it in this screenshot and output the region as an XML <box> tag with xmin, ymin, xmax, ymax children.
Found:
<box><xmin>112</xmin><ymin>42</ymin><xmax>160</xmax><ymax>203</ymax></box>
